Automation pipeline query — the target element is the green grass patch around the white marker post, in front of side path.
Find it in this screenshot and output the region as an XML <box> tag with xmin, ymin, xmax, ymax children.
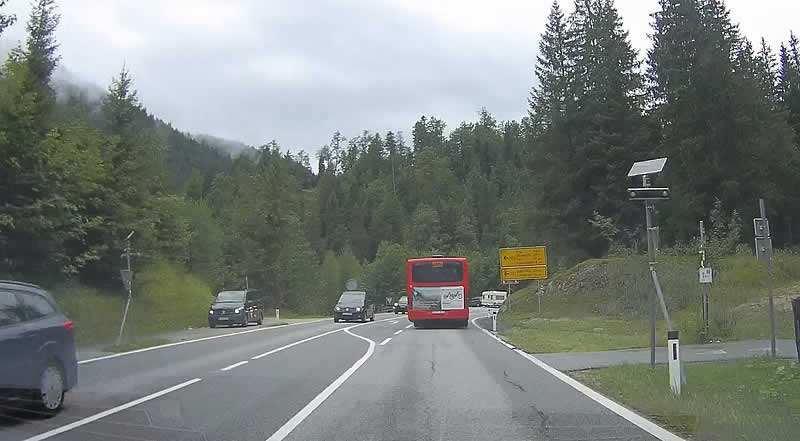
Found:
<box><xmin>573</xmin><ymin>358</ymin><xmax>800</xmax><ymax>441</ymax></box>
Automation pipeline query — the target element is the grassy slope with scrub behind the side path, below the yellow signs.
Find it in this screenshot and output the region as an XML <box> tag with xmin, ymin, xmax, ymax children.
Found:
<box><xmin>499</xmin><ymin>253</ymin><xmax>800</xmax><ymax>352</ymax></box>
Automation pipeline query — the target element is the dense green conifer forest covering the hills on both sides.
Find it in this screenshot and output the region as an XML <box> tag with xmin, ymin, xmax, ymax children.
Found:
<box><xmin>0</xmin><ymin>0</ymin><xmax>800</xmax><ymax>312</ymax></box>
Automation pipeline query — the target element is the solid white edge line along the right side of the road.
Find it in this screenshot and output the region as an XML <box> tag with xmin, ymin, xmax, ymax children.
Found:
<box><xmin>472</xmin><ymin>317</ymin><xmax>686</xmax><ymax>441</ymax></box>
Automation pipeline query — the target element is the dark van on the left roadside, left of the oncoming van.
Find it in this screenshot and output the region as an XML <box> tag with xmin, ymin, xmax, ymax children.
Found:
<box><xmin>208</xmin><ymin>289</ymin><xmax>264</xmax><ymax>328</ymax></box>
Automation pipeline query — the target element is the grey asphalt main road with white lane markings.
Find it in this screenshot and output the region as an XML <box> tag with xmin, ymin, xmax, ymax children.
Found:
<box><xmin>0</xmin><ymin>310</ymin><xmax>679</xmax><ymax>441</ymax></box>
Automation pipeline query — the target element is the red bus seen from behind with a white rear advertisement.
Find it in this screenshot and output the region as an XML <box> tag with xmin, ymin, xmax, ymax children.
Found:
<box><xmin>406</xmin><ymin>256</ymin><xmax>469</xmax><ymax>328</ymax></box>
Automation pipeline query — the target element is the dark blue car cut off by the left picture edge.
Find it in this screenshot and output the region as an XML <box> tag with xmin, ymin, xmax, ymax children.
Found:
<box><xmin>0</xmin><ymin>280</ymin><xmax>78</xmax><ymax>412</ymax></box>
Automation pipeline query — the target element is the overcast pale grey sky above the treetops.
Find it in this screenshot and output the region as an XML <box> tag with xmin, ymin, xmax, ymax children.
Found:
<box><xmin>2</xmin><ymin>0</ymin><xmax>800</xmax><ymax>152</ymax></box>
